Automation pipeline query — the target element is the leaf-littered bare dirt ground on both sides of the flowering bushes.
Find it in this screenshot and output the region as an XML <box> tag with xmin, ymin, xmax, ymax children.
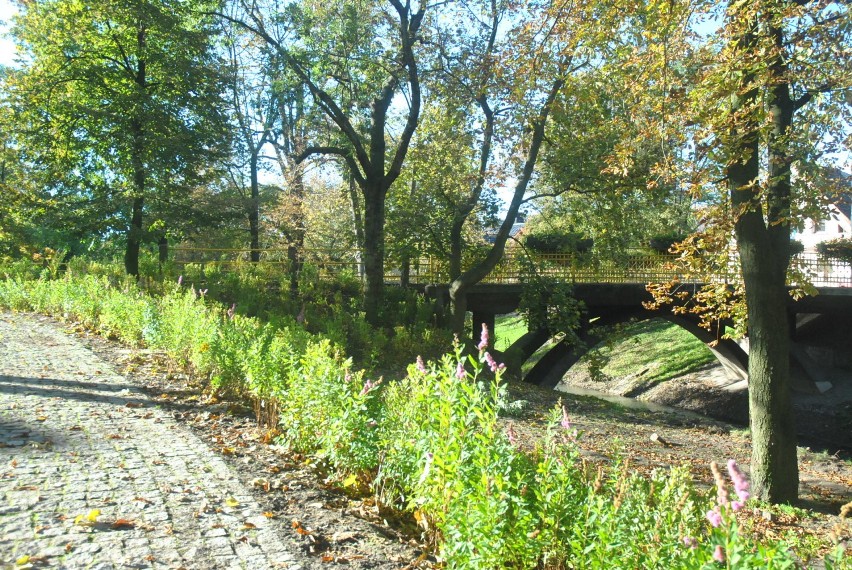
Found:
<box><xmin>70</xmin><ymin>322</ymin><xmax>852</xmax><ymax>568</ymax></box>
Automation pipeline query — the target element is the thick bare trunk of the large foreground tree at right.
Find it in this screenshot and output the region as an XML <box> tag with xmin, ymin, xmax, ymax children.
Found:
<box><xmin>727</xmin><ymin>6</ymin><xmax>799</xmax><ymax>503</ymax></box>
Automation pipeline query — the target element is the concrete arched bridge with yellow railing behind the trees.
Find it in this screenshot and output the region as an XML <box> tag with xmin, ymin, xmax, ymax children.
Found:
<box><xmin>174</xmin><ymin>248</ymin><xmax>852</xmax><ymax>391</ymax></box>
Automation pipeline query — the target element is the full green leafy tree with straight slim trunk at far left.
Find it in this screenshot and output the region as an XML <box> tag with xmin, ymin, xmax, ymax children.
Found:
<box><xmin>6</xmin><ymin>0</ymin><xmax>227</xmax><ymax>275</ymax></box>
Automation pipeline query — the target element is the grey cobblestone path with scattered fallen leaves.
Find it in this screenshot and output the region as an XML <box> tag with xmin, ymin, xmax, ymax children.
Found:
<box><xmin>0</xmin><ymin>313</ymin><xmax>299</xmax><ymax>569</ymax></box>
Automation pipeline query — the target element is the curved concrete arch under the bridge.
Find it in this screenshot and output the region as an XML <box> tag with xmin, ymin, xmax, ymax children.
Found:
<box><xmin>505</xmin><ymin>309</ymin><xmax>748</xmax><ymax>388</ymax></box>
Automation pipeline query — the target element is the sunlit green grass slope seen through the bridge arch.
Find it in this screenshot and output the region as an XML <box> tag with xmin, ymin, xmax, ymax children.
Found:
<box><xmin>598</xmin><ymin>319</ymin><xmax>715</xmax><ymax>385</ymax></box>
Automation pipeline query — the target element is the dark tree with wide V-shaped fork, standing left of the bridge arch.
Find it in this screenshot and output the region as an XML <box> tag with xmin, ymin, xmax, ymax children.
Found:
<box><xmin>220</xmin><ymin>0</ymin><xmax>426</xmax><ymax>325</ymax></box>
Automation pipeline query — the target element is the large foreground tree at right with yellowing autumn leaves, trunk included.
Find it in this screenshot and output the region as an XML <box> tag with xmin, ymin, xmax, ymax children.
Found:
<box><xmin>633</xmin><ymin>0</ymin><xmax>850</xmax><ymax>502</ymax></box>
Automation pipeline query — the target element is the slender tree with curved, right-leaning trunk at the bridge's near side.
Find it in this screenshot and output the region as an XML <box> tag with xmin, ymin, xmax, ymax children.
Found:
<box><xmin>422</xmin><ymin>0</ymin><xmax>624</xmax><ymax>332</ymax></box>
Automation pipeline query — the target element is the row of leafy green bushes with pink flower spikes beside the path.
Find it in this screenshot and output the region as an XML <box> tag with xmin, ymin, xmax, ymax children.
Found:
<box><xmin>0</xmin><ymin>264</ymin><xmax>812</xmax><ymax>569</ymax></box>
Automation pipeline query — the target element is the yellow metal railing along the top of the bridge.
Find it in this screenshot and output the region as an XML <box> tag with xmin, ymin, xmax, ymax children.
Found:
<box><xmin>172</xmin><ymin>247</ymin><xmax>852</xmax><ymax>287</ymax></box>
